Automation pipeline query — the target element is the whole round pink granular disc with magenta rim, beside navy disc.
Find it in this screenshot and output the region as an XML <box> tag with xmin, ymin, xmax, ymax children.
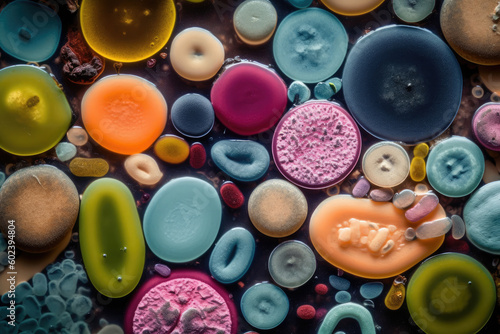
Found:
<box><xmin>274</xmin><ymin>102</ymin><xmax>361</xmax><ymax>187</ymax></box>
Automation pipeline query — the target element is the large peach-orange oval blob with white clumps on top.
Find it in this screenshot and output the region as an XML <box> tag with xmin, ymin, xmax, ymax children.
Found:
<box><xmin>309</xmin><ymin>195</ymin><xmax>446</xmax><ymax>279</ymax></box>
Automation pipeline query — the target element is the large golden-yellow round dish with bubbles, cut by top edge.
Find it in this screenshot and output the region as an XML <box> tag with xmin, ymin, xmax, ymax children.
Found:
<box><xmin>80</xmin><ymin>0</ymin><xmax>176</xmax><ymax>62</ymax></box>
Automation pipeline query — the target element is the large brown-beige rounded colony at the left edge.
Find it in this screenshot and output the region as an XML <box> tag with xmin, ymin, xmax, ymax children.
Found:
<box><xmin>0</xmin><ymin>165</ymin><xmax>80</xmax><ymax>253</ymax></box>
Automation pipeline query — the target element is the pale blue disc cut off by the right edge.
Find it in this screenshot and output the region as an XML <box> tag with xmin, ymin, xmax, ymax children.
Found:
<box><xmin>463</xmin><ymin>181</ymin><xmax>500</xmax><ymax>255</ymax></box>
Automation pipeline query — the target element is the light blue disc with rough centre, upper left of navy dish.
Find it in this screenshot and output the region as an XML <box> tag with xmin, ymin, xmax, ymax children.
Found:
<box><xmin>273</xmin><ymin>8</ymin><xmax>348</xmax><ymax>83</ymax></box>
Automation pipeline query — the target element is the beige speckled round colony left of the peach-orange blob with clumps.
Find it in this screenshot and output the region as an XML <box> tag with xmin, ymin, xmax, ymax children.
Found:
<box><xmin>248</xmin><ymin>179</ymin><xmax>307</xmax><ymax>238</ymax></box>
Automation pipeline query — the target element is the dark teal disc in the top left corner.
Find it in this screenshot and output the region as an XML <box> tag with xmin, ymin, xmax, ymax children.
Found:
<box><xmin>0</xmin><ymin>0</ymin><xmax>62</xmax><ymax>62</ymax></box>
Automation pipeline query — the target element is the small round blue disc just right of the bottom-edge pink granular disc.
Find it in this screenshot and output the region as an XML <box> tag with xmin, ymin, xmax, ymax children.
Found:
<box><xmin>240</xmin><ymin>283</ymin><xmax>290</xmax><ymax>330</ymax></box>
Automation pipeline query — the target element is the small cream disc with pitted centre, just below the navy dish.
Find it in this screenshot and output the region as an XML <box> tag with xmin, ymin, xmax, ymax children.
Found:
<box><xmin>362</xmin><ymin>141</ymin><xmax>410</xmax><ymax>188</ymax></box>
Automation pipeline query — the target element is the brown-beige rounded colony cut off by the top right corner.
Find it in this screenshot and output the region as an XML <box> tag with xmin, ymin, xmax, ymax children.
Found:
<box><xmin>440</xmin><ymin>0</ymin><xmax>500</xmax><ymax>65</ymax></box>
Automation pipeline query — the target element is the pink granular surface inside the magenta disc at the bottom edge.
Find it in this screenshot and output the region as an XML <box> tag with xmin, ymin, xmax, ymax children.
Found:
<box><xmin>133</xmin><ymin>278</ymin><xmax>231</xmax><ymax>334</ymax></box>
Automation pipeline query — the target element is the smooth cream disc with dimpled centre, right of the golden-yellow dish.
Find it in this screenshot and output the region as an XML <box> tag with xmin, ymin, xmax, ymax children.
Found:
<box><xmin>170</xmin><ymin>27</ymin><xmax>224</xmax><ymax>81</ymax></box>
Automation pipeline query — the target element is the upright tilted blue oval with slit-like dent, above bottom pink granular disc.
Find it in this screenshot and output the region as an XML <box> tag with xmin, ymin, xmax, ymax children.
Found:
<box><xmin>208</xmin><ymin>227</ymin><xmax>255</xmax><ymax>284</ymax></box>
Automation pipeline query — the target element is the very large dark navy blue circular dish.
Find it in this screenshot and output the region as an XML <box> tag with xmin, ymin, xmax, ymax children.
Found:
<box><xmin>342</xmin><ymin>25</ymin><xmax>462</xmax><ymax>145</ymax></box>
